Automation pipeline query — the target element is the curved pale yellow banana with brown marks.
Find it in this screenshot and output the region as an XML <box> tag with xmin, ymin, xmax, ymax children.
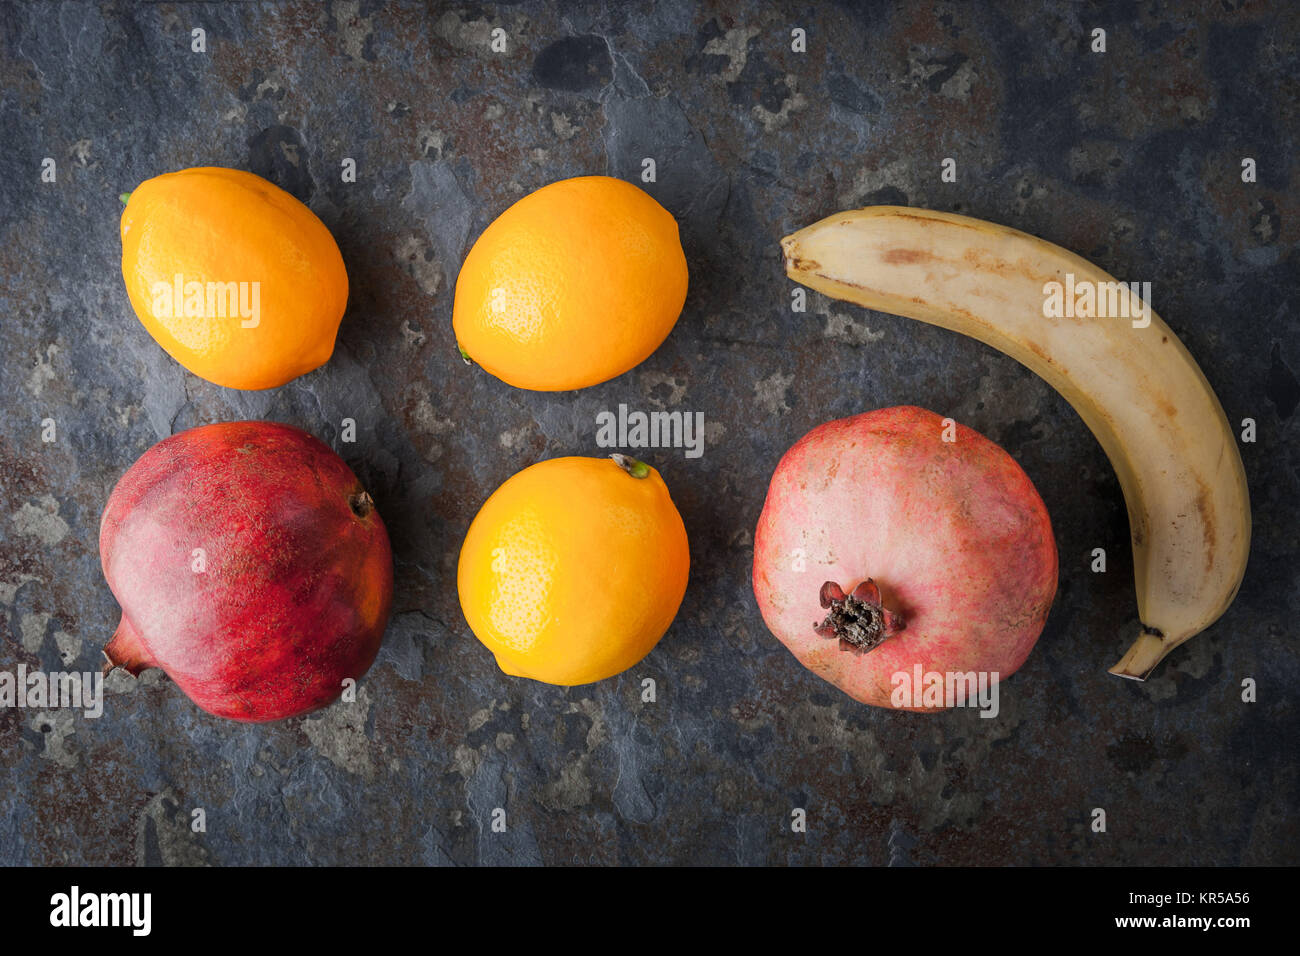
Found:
<box><xmin>781</xmin><ymin>206</ymin><xmax>1251</xmax><ymax>680</ymax></box>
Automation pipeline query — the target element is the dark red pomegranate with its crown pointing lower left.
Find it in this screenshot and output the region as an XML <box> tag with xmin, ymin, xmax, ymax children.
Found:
<box><xmin>99</xmin><ymin>421</ymin><xmax>393</xmax><ymax>721</ymax></box>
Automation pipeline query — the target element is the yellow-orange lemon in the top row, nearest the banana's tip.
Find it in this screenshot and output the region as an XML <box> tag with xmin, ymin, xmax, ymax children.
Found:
<box><xmin>452</xmin><ymin>176</ymin><xmax>686</xmax><ymax>392</ymax></box>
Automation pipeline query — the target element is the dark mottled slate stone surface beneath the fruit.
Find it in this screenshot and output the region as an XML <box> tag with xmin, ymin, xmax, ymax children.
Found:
<box><xmin>0</xmin><ymin>0</ymin><xmax>1300</xmax><ymax>864</ymax></box>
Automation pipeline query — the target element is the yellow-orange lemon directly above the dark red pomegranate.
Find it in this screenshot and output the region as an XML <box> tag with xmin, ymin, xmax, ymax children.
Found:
<box><xmin>121</xmin><ymin>166</ymin><xmax>347</xmax><ymax>389</ymax></box>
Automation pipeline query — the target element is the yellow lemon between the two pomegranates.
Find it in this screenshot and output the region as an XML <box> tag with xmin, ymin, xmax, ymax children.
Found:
<box><xmin>456</xmin><ymin>455</ymin><xmax>690</xmax><ymax>685</ymax></box>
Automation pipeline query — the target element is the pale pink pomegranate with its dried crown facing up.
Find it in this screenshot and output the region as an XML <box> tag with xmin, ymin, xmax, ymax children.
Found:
<box><xmin>754</xmin><ymin>406</ymin><xmax>1057</xmax><ymax>710</ymax></box>
